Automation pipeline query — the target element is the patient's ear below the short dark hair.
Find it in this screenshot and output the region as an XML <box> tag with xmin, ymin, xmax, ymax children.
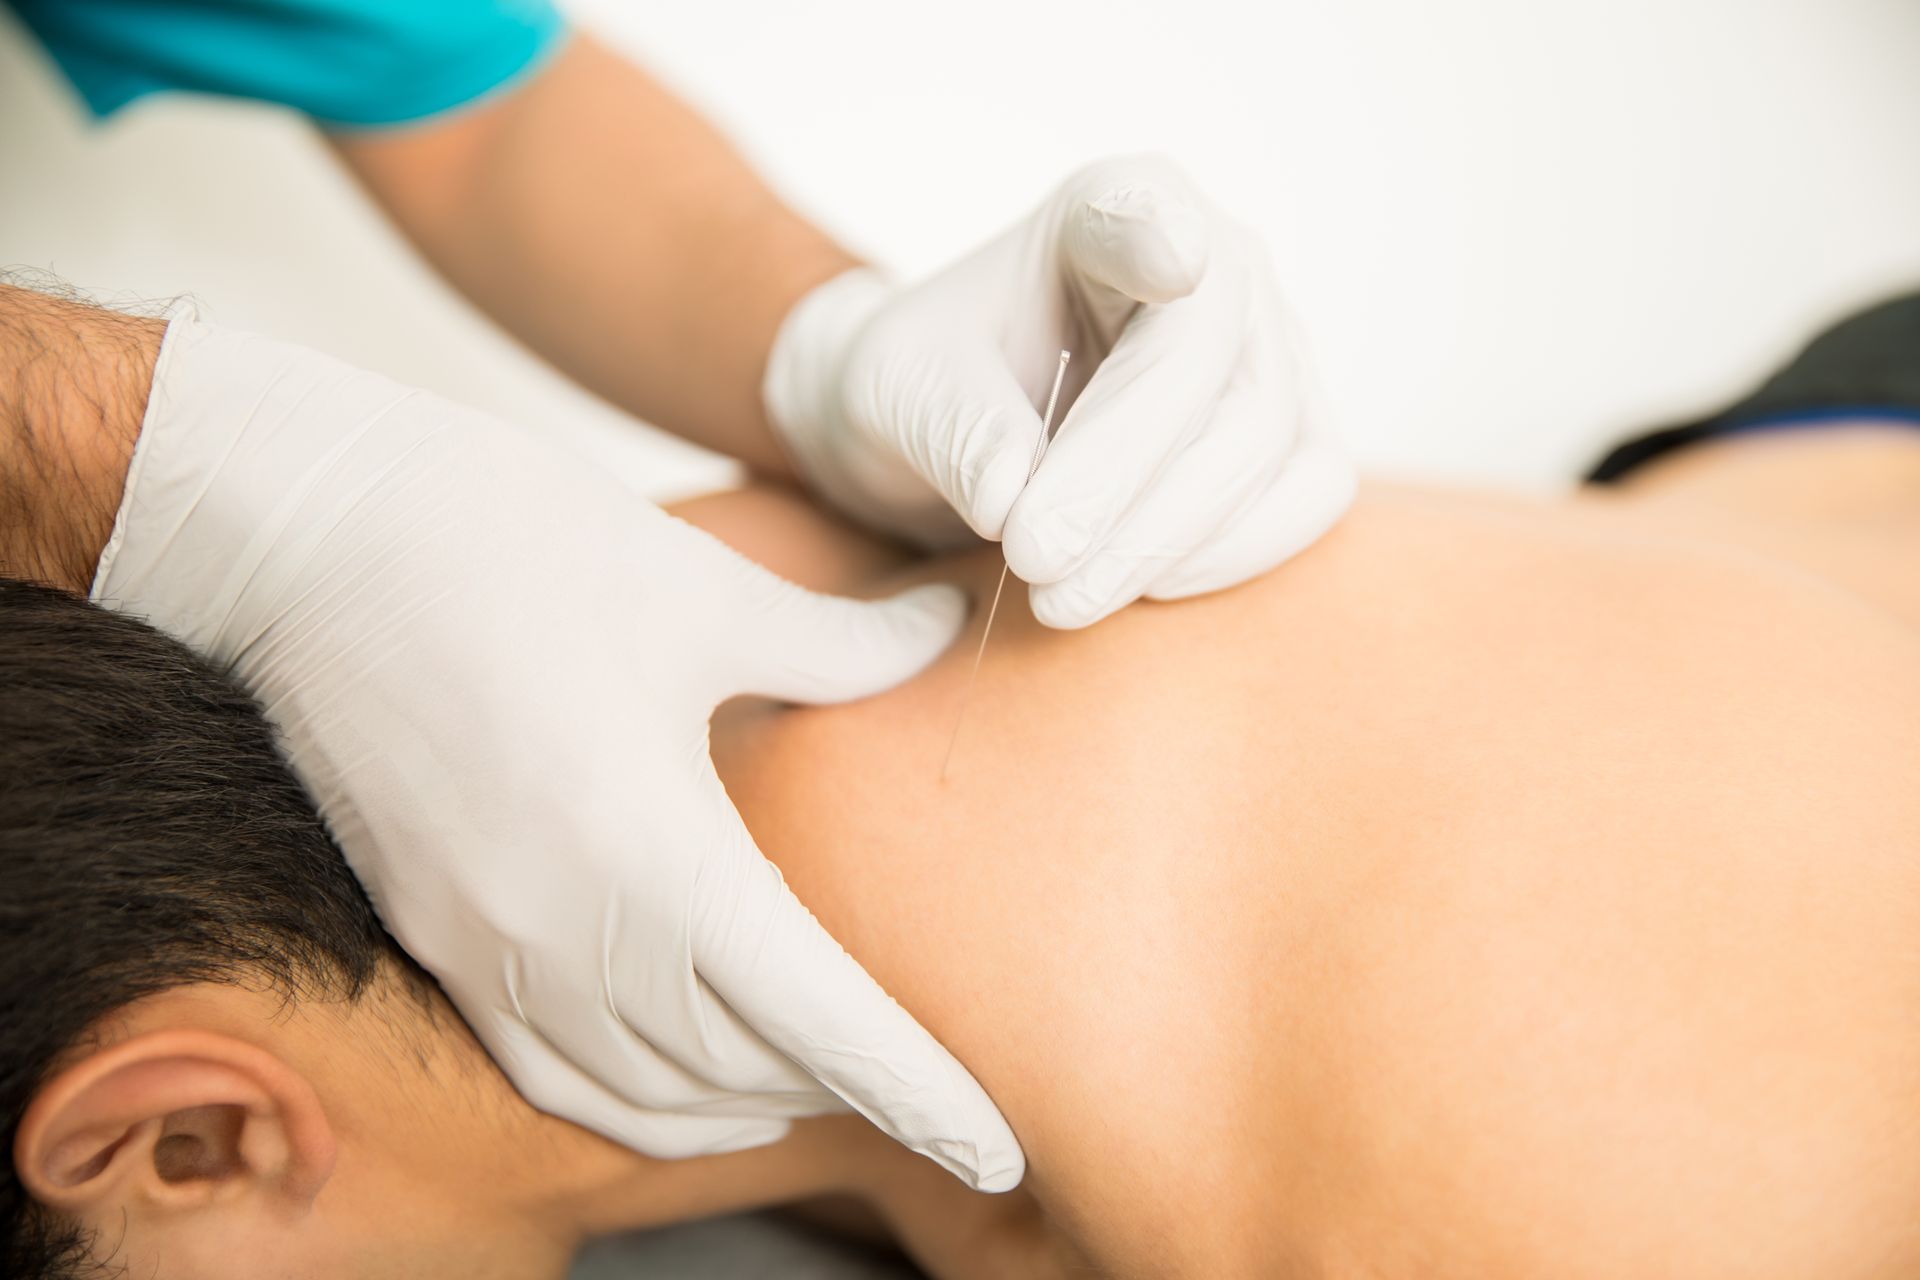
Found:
<box><xmin>13</xmin><ymin>1031</ymin><xmax>334</xmax><ymax>1221</ymax></box>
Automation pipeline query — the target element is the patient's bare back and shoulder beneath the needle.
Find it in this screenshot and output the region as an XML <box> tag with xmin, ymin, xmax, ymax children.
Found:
<box><xmin>687</xmin><ymin>470</ymin><xmax>1920</xmax><ymax>1276</ymax></box>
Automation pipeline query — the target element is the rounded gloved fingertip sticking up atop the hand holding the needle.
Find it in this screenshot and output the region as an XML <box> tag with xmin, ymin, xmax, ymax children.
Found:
<box><xmin>1060</xmin><ymin>155</ymin><xmax>1210</xmax><ymax>316</ymax></box>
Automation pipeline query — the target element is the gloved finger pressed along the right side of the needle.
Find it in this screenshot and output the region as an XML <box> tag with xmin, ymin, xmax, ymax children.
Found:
<box><xmin>1002</xmin><ymin>271</ymin><xmax>1248</xmax><ymax>583</ymax></box>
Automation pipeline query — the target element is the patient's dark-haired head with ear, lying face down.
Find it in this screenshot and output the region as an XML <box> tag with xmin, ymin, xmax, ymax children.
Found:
<box><xmin>0</xmin><ymin>580</ymin><xmax>645</xmax><ymax>1278</ymax></box>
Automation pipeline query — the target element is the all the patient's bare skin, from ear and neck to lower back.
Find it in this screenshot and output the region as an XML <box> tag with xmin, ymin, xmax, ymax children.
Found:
<box><xmin>15</xmin><ymin>428</ymin><xmax>1920</xmax><ymax>1280</ymax></box>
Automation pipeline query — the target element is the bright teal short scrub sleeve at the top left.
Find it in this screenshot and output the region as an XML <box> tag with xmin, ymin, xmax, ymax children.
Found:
<box><xmin>12</xmin><ymin>0</ymin><xmax>564</xmax><ymax>129</ymax></box>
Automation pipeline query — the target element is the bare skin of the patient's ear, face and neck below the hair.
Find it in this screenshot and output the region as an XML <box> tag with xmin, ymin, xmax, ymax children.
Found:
<box><xmin>13</xmin><ymin>975</ymin><xmax>1060</xmax><ymax>1280</ymax></box>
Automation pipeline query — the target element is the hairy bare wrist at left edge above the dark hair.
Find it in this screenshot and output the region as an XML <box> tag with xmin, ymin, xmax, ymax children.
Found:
<box><xmin>0</xmin><ymin>284</ymin><xmax>167</xmax><ymax>593</ymax></box>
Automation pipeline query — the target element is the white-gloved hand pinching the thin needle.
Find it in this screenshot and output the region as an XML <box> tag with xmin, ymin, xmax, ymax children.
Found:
<box><xmin>764</xmin><ymin>157</ymin><xmax>1354</xmax><ymax>628</ymax></box>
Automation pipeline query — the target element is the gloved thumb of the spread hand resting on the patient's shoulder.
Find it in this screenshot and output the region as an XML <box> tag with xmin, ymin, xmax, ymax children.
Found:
<box><xmin>737</xmin><ymin>566</ymin><xmax>968</xmax><ymax>702</ymax></box>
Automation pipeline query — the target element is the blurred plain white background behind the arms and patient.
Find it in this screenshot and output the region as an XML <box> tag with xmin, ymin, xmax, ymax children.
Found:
<box><xmin>0</xmin><ymin>0</ymin><xmax>1920</xmax><ymax>493</ymax></box>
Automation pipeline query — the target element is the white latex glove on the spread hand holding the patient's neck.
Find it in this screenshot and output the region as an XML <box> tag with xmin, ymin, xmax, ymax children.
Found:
<box><xmin>92</xmin><ymin>319</ymin><xmax>1023</xmax><ymax>1190</ymax></box>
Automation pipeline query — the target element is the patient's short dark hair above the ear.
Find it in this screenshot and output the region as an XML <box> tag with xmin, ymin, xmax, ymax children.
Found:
<box><xmin>0</xmin><ymin>578</ymin><xmax>397</xmax><ymax>1280</ymax></box>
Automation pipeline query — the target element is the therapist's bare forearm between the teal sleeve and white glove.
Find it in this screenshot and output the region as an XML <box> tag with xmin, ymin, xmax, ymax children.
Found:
<box><xmin>332</xmin><ymin>36</ymin><xmax>854</xmax><ymax>476</ymax></box>
